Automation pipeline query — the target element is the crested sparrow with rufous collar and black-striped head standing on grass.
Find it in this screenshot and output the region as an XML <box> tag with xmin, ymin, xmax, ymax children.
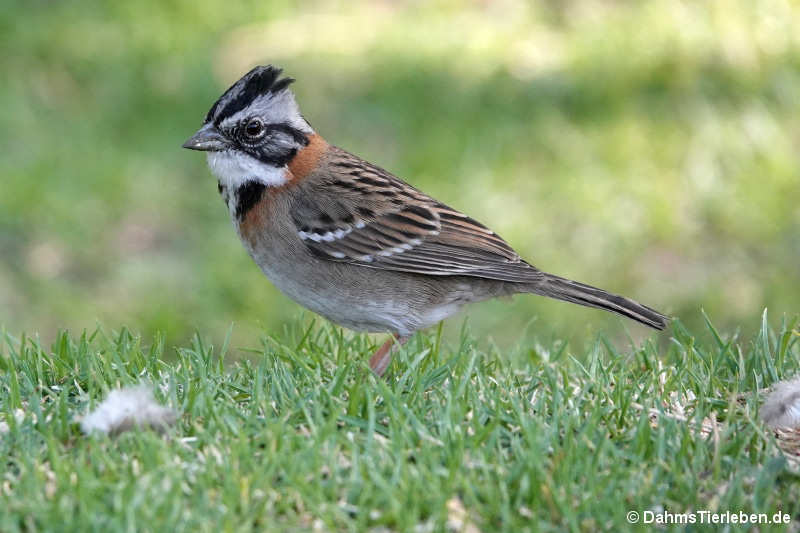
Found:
<box><xmin>183</xmin><ymin>65</ymin><xmax>669</xmax><ymax>376</ymax></box>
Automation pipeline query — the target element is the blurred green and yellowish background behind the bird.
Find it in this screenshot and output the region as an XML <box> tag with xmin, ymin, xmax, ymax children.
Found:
<box><xmin>0</xmin><ymin>0</ymin><xmax>800</xmax><ymax>352</ymax></box>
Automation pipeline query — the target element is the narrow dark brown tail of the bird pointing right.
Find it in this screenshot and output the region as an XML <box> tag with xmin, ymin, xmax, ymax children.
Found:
<box><xmin>529</xmin><ymin>274</ymin><xmax>669</xmax><ymax>330</ymax></box>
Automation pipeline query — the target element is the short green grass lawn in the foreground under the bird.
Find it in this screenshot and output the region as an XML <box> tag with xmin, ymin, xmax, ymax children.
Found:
<box><xmin>0</xmin><ymin>313</ymin><xmax>800</xmax><ymax>533</ymax></box>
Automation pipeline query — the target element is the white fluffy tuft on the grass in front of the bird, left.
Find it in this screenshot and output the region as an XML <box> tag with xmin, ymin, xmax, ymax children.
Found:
<box><xmin>81</xmin><ymin>385</ymin><xmax>178</xmax><ymax>435</ymax></box>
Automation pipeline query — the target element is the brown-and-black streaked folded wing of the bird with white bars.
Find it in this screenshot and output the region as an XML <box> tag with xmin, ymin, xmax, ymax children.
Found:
<box><xmin>292</xmin><ymin>150</ymin><xmax>541</xmax><ymax>282</ymax></box>
